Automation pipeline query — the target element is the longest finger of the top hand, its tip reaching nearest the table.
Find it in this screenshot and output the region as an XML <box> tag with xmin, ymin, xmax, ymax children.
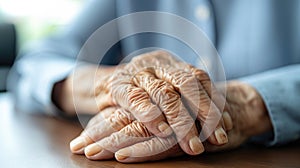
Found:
<box><xmin>133</xmin><ymin>68</ymin><xmax>203</xmax><ymax>155</ymax></box>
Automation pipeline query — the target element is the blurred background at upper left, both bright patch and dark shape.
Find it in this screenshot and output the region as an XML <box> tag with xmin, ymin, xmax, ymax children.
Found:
<box><xmin>0</xmin><ymin>0</ymin><xmax>84</xmax><ymax>91</ymax></box>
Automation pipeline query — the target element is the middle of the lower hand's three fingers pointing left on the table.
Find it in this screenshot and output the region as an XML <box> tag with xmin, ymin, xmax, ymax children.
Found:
<box><xmin>85</xmin><ymin>121</ymin><xmax>152</xmax><ymax>160</ymax></box>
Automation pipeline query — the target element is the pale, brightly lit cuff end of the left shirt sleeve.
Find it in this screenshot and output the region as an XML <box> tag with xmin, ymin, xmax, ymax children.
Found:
<box><xmin>8</xmin><ymin>54</ymin><xmax>75</xmax><ymax>115</ymax></box>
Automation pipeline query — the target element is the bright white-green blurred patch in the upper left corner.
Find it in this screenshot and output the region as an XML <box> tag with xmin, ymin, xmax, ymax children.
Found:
<box><xmin>0</xmin><ymin>0</ymin><xmax>83</xmax><ymax>46</ymax></box>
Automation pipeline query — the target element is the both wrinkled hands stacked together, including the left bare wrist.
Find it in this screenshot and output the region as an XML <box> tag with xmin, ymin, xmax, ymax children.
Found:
<box><xmin>61</xmin><ymin>51</ymin><xmax>254</xmax><ymax>162</ymax></box>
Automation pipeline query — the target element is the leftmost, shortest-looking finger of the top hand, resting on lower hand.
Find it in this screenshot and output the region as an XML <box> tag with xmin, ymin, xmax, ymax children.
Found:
<box><xmin>112</xmin><ymin>73</ymin><xmax>171</xmax><ymax>137</ymax></box>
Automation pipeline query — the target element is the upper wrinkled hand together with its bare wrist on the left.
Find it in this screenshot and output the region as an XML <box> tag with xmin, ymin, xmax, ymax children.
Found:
<box><xmin>54</xmin><ymin>51</ymin><xmax>232</xmax><ymax>155</ymax></box>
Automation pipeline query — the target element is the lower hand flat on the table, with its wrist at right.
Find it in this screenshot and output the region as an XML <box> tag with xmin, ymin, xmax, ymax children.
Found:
<box><xmin>69</xmin><ymin>82</ymin><xmax>272</xmax><ymax>163</ymax></box>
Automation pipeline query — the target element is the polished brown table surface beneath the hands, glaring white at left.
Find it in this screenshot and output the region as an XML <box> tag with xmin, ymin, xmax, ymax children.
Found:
<box><xmin>0</xmin><ymin>93</ymin><xmax>300</xmax><ymax>168</ymax></box>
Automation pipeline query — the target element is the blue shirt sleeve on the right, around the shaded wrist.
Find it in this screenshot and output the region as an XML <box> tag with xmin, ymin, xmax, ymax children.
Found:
<box><xmin>240</xmin><ymin>64</ymin><xmax>300</xmax><ymax>146</ymax></box>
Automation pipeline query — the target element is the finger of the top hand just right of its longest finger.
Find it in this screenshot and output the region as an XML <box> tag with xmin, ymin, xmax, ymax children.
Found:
<box><xmin>156</xmin><ymin>69</ymin><xmax>227</xmax><ymax>144</ymax></box>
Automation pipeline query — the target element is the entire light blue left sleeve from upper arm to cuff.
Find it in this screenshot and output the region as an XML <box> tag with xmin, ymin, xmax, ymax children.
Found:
<box><xmin>7</xmin><ymin>0</ymin><xmax>115</xmax><ymax>115</ymax></box>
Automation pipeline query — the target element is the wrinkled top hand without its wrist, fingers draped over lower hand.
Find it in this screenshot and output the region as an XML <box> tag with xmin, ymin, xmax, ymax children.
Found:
<box><xmin>109</xmin><ymin>51</ymin><xmax>231</xmax><ymax>155</ymax></box>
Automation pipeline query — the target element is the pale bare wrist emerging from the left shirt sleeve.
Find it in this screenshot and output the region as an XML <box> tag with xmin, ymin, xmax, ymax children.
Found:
<box><xmin>52</xmin><ymin>64</ymin><xmax>120</xmax><ymax>116</ymax></box>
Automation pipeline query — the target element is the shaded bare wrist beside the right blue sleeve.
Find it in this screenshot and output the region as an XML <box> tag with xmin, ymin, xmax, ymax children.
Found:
<box><xmin>226</xmin><ymin>81</ymin><xmax>272</xmax><ymax>138</ymax></box>
